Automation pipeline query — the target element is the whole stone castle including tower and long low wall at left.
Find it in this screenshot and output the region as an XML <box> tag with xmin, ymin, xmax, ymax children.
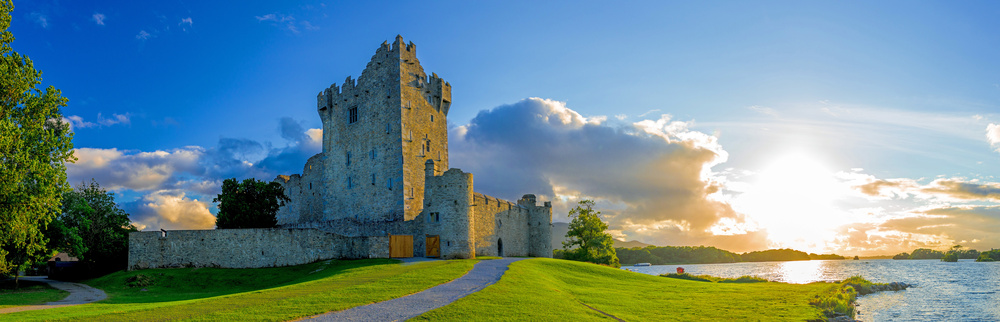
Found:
<box><xmin>129</xmin><ymin>36</ymin><xmax>552</xmax><ymax>269</ymax></box>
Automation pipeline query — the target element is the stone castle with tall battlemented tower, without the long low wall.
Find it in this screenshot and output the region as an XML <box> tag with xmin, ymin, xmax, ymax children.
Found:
<box><xmin>276</xmin><ymin>36</ymin><xmax>552</xmax><ymax>258</ymax></box>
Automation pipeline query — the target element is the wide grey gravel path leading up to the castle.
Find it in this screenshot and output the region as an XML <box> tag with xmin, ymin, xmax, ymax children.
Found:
<box><xmin>308</xmin><ymin>258</ymin><xmax>524</xmax><ymax>321</ymax></box>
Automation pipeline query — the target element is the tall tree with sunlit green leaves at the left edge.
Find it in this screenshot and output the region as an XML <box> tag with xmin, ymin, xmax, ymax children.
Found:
<box><xmin>0</xmin><ymin>0</ymin><xmax>76</xmax><ymax>282</ymax></box>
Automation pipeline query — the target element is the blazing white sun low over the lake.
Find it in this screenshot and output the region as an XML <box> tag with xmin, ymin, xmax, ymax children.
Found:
<box><xmin>733</xmin><ymin>153</ymin><xmax>847</xmax><ymax>252</ymax></box>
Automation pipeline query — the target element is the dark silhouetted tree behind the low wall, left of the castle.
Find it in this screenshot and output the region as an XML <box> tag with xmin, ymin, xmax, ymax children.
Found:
<box><xmin>212</xmin><ymin>178</ymin><xmax>291</xmax><ymax>229</ymax></box>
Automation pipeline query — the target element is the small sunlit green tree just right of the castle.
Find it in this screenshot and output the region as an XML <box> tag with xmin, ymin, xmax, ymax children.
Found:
<box><xmin>563</xmin><ymin>200</ymin><xmax>621</xmax><ymax>267</ymax></box>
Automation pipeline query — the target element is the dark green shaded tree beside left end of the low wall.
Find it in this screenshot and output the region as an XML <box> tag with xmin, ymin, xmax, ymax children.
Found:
<box><xmin>46</xmin><ymin>180</ymin><xmax>138</xmax><ymax>273</ymax></box>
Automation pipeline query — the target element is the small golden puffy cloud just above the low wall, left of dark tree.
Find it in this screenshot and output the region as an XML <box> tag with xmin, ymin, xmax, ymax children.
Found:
<box><xmin>123</xmin><ymin>190</ymin><xmax>215</xmax><ymax>230</ymax></box>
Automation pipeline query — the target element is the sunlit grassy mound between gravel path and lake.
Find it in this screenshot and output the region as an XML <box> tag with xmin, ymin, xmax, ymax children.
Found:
<box><xmin>417</xmin><ymin>258</ymin><xmax>839</xmax><ymax>321</ymax></box>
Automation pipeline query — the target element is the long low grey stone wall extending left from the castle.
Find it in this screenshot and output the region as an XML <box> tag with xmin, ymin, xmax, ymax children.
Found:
<box><xmin>128</xmin><ymin>228</ymin><xmax>389</xmax><ymax>270</ymax></box>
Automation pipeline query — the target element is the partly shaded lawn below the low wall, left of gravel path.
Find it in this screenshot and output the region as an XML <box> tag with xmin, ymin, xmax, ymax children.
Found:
<box><xmin>0</xmin><ymin>259</ymin><xmax>476</xmax><ymax>321</ymax></box>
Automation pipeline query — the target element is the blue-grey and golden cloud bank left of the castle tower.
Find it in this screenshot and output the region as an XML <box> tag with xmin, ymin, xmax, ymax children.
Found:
<box><xmin>66</xmin><ymin>118</ymin><xmax>322</xmax><ymax>230</ymax></box>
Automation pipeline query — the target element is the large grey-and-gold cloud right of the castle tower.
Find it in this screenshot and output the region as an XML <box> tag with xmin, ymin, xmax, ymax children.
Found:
<box><xmin>449</xmin><ymin>98</ymin><xmax>764</xmax><ymax>251</ymax></box>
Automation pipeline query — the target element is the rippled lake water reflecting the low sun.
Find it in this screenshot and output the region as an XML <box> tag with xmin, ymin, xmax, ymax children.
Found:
<box><xmin>622</xmin><ymin>259</ymin><xmax>1000</xmax><ymax>321</ymax></box>
